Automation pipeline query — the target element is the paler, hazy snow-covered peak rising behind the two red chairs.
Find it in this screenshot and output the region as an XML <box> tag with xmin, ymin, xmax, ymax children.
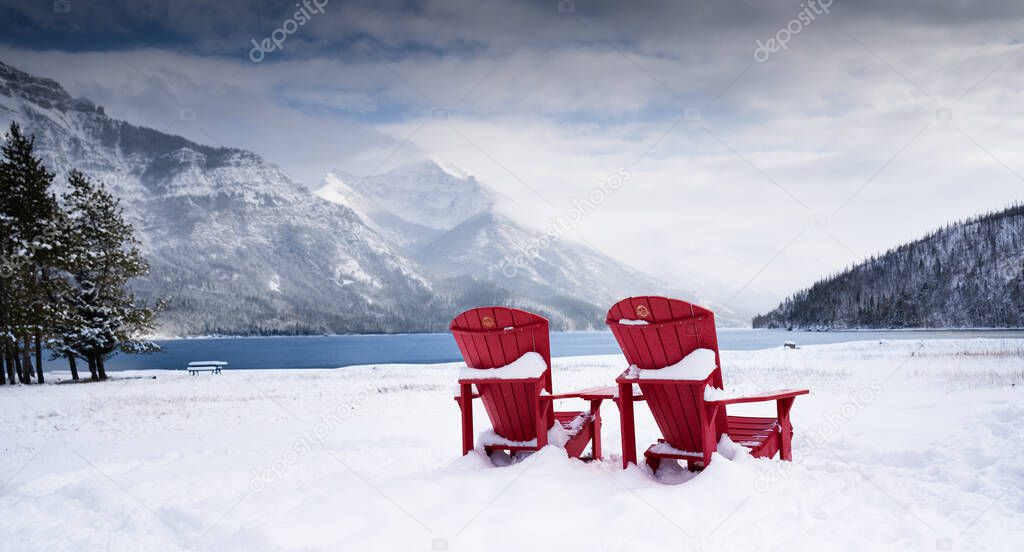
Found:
<box><xmin>316</xmin><ymin>161</ymin><xmax>742</xmax><ymax>328</ymax></box>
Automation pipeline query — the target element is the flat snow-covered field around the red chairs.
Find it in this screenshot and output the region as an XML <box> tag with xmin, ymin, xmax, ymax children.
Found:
<box><xmin>0</xmin><ymin>340</ymin><xmax>1024</xmax><ymax>551</ymax></box>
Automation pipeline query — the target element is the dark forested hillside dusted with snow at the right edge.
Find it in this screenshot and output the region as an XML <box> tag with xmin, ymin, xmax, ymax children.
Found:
<box><xmin>754</xmin><ymin>205</ymin><xmax>1024</xmax><ymax>329</ymax></box>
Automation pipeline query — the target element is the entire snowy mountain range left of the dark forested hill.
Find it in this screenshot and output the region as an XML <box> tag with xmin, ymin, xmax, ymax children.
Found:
<box><xmin>0</xmin><ymin>62</ymin><xmax>735</xmax><ymax>335</ymax></box>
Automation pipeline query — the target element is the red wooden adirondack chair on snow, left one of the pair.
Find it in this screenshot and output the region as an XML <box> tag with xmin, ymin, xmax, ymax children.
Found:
<box><xmin>450</xmin><ymin>306</ymin><xmax>601</xmax><ymax>459</ymax></box>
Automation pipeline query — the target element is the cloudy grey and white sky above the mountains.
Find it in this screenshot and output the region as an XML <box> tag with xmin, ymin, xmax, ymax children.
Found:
<box><xmin>0</xmin><ymin>0</ymin><xmax>1024</xmax><ymax>309</ymax></box>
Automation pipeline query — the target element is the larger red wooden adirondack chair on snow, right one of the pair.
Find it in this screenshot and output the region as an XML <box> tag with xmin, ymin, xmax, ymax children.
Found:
<box><xmin>605</xmin><ymin>297</ymin><xmax>810</xmax><ymax>470</ymax></box>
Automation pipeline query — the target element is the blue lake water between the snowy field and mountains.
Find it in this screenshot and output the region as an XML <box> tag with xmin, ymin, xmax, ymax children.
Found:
<box><xmin>46</xmin><ymin>329</ymin><xmax>1024</xmax><ymax>370</ymax></box>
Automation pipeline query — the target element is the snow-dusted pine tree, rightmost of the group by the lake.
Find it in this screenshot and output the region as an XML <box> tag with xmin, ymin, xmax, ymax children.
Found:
<box><xmin>57</xmin><ymin>171</ymin><xmax>163</xmax><ymax>379</ymax></box>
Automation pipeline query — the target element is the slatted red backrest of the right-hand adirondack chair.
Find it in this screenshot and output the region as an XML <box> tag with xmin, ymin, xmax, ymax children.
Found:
<box><xmin>605</xmin><ymin>297</ymin><xmax>723</xmax><ymax>452</ymax></box>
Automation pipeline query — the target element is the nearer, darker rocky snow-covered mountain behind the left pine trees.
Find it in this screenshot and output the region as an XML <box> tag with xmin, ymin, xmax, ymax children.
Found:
<box><xmin>0</xmin><ymin>63</ymin><xmax>441</xmax><ymax>334</ymax></box>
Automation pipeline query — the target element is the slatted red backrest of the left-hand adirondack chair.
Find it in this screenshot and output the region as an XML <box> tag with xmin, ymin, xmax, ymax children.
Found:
<box><xmin>449</xmin><ymin>306</ymin><xmax>554</xmax><ymax>441</ymax></box>
